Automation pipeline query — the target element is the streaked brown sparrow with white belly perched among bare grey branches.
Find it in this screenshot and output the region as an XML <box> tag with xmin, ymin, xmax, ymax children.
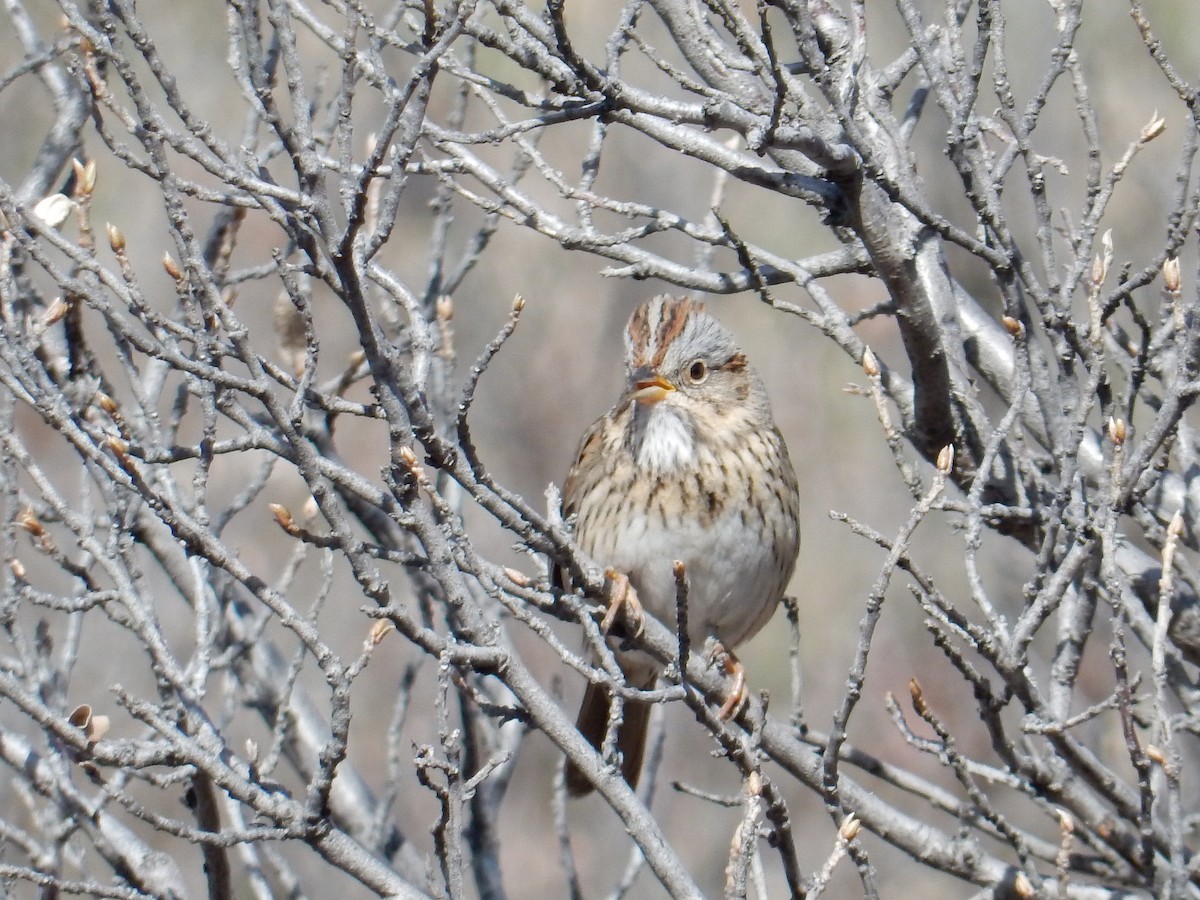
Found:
<box><xmin>563</xmin><ymin>295</ymin><xmax>800</xmax><ymax>796</ymax></box>
